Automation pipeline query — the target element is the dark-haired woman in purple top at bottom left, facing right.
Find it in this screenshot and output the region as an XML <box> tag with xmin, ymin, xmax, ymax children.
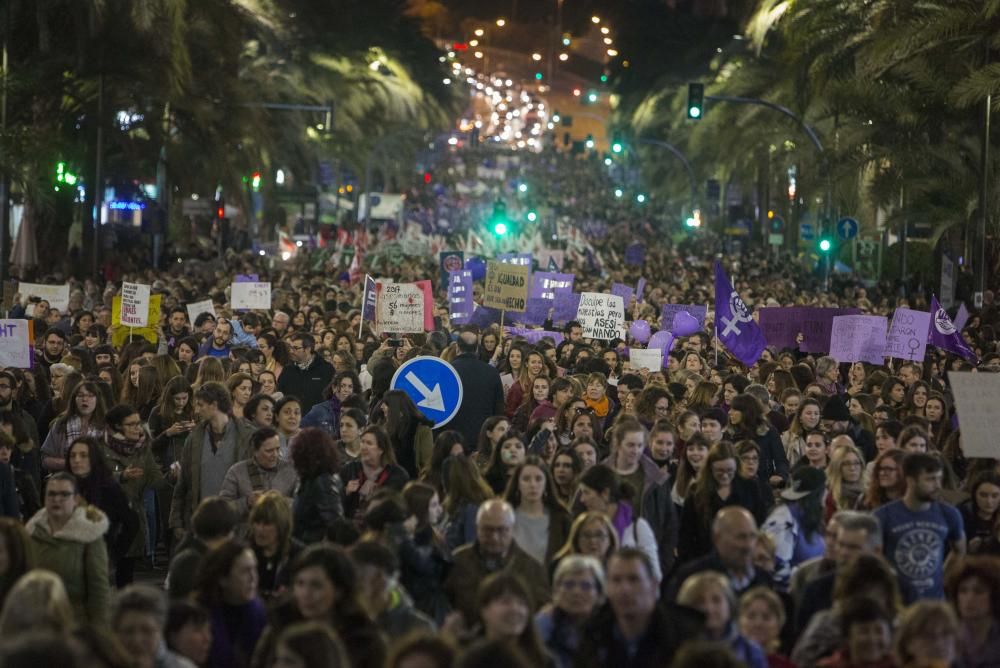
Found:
<box><xmin>195</xmin><ymin>539</ymin><xmax>267</xmax><ymax>668</ymax></box>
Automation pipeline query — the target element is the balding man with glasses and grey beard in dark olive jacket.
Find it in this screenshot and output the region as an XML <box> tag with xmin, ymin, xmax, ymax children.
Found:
<box><xmin>444</xmin><ymin>499</ymin><xmax>549</xmax><ymax>627</ymax></box>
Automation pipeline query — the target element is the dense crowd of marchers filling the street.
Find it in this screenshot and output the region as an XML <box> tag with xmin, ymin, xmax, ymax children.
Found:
<box><xmin>0</xmin><ymin>147</ymin><xmax>1000</xmax><ymax>668</ymax></box>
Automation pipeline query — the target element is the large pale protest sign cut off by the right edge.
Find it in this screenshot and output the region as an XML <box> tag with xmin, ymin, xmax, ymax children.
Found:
<box><xmin>948</xmin><ymin>371</ymin><xmax>1000</xmax><ymax>459</ymax></box>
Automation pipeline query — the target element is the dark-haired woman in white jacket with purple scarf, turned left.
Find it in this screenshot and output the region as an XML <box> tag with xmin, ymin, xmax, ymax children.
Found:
<box><xmin>580</xmin><ymin>464</ymin><xmax>662</xmax><ymax>581</ymax></box>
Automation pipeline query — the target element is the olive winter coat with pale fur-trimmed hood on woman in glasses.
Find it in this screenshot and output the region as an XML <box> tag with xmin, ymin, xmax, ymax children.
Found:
<box><xmin>25</xmin><ymin>506</ymin><xmax>111</xmax><ymax>626</ymax></box>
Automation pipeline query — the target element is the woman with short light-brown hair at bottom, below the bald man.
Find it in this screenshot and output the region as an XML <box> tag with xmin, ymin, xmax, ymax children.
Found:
<box><xmin>677</xmin><ymin>571</ymin><xmax>767</xmax><ymax>668</ymax></box>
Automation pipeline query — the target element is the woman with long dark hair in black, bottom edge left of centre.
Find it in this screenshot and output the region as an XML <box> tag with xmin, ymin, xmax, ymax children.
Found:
<box><xmin>252</xmin><ymin>545</ymin><xmax>386</xmax><ymax>668</ymax></box>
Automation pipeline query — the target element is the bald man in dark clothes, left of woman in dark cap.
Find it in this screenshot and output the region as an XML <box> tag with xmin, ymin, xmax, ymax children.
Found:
<box><xmin>667</xmin><ymin>506</ymin><xmax>771</xmax><ymax>601</ymax></box>
